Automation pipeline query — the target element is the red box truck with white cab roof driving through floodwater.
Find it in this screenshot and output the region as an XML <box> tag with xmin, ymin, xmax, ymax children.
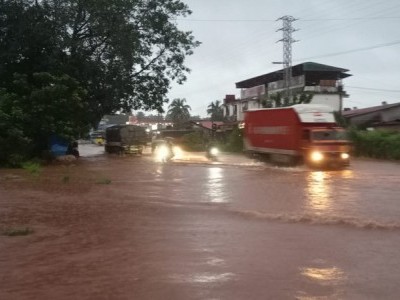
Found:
<box><xmin>244</xmin><ymin>104</ymin><xmax>351</xmax><ymax>167</ymax></box>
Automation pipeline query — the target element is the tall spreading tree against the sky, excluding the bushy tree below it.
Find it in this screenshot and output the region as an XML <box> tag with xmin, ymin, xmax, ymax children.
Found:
<box><xmin>0</xmin><ymin>0</ymin><xmax>199</xmax><ymax>125</ymax></box>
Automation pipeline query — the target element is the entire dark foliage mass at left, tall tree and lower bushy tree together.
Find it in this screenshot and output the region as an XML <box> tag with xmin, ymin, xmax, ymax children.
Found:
<box><xmin>0</xmin><ymin>0</ymin><xmax>199</xmax><ymax>164</ymax></box>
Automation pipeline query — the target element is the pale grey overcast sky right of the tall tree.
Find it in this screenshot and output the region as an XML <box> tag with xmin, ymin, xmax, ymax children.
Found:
<box><xmin>165</xmin><ymin>0</ymin><xmax>400</xmax><ymax>117</ymax></box>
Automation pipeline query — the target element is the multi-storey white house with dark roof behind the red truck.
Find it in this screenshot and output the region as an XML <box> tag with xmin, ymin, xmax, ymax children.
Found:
<box><xmin>223</xmin><ymin>62</ymin><xmax>351</xmax><ymax>121</ymax></box>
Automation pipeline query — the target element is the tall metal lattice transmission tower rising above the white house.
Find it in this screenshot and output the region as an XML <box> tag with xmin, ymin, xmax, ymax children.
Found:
<box><xmin>277</xmin><ymin>16</ymin><xmax>297</xmax><ymax>101</ymax></box>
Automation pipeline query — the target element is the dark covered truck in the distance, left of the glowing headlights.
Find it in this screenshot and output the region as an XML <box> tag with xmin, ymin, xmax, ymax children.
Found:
<box><xmin>104</xmin><ymin>125</ymin><xmax>148</xmax><ymax>154</ymax></box>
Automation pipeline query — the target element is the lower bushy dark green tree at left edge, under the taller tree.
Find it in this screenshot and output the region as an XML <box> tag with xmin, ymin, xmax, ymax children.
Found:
<box><xmin>0</xmin><ymin>73</ymin><xmax>88</xmax><ymax>164</ymax></box>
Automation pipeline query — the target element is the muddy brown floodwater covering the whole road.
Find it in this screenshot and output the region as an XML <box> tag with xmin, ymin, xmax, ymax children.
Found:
<box><xmin>0</xmin><ymin>145</ymin><xmax>400</xmax><ymax>300</ymax></box>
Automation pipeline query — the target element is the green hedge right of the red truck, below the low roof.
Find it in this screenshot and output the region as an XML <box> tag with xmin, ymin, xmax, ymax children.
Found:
<box><xmin>349</xmin><ymin>130</ymin><xmax>400</xmax><ymax>159</ymax></box>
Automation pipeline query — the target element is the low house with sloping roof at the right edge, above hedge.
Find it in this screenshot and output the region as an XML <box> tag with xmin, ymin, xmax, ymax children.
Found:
<box><xmin>342</xmin><ymin>102</ymin><xmax>400</xmax><ymax>130</ymax></box>
